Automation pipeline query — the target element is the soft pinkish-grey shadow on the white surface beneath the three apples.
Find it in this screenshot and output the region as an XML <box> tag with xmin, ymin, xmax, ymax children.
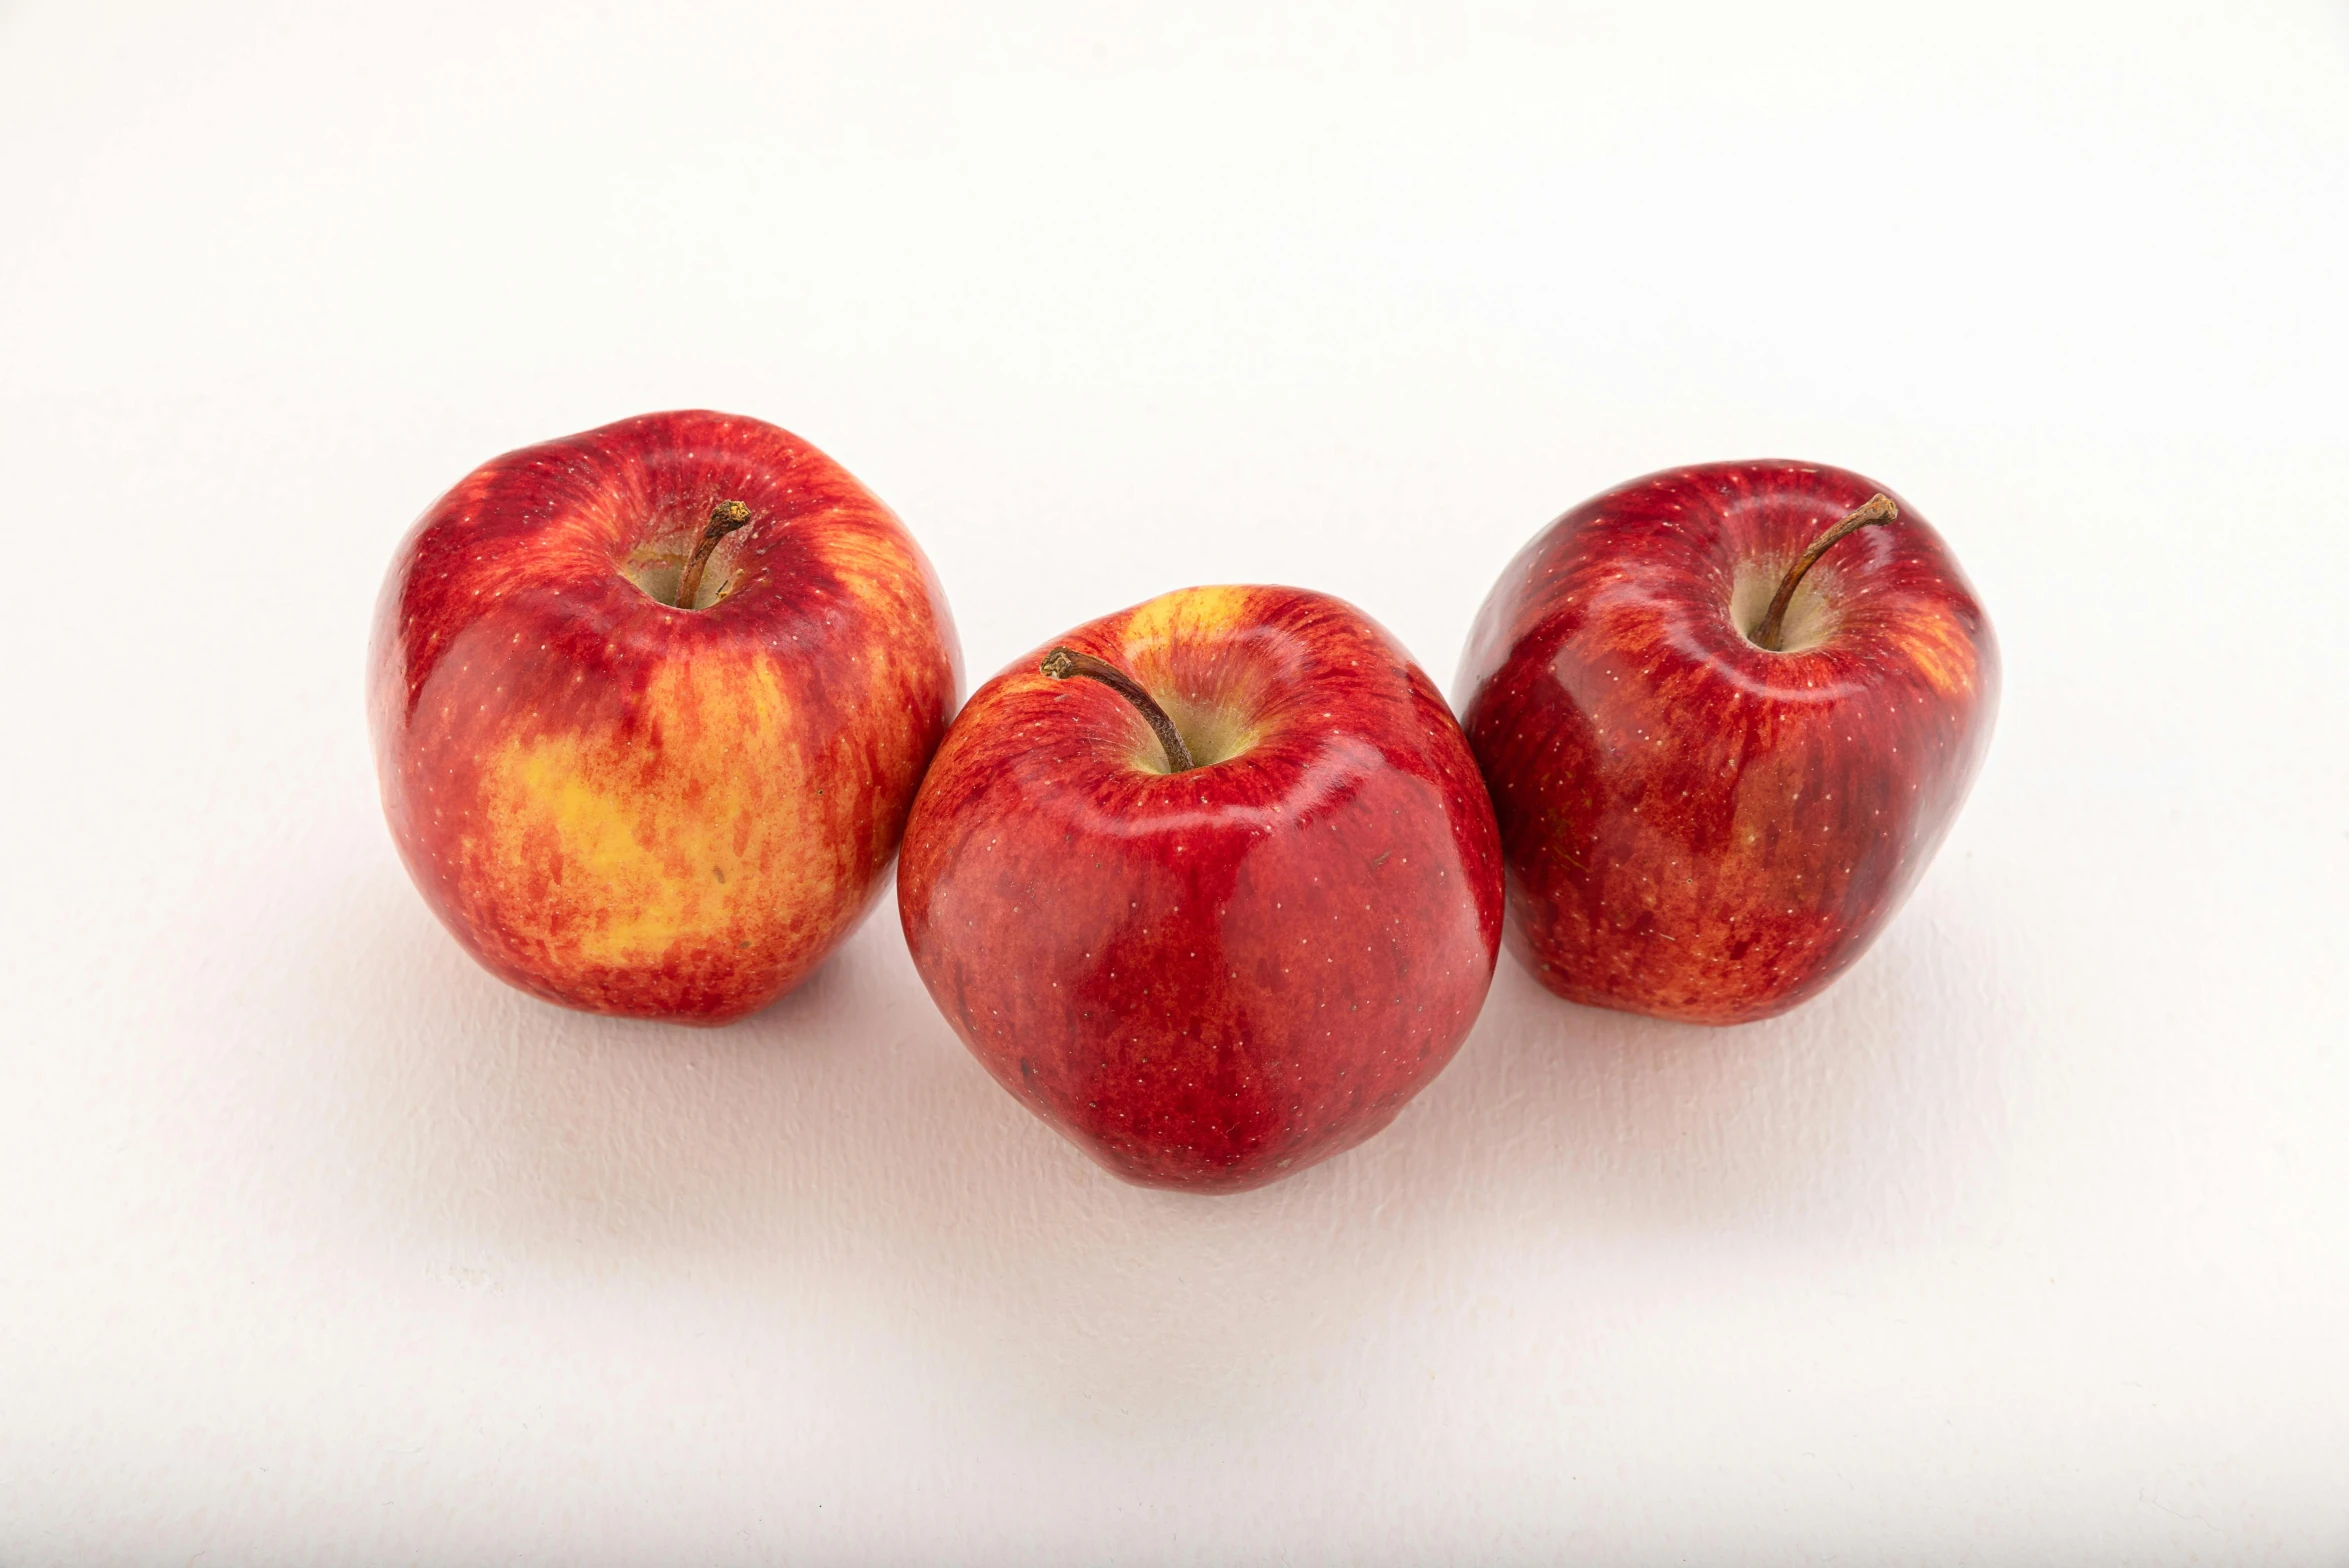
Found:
<box><xmin>294</xmin><ymin>857</ymin><xmax>1999</xmax><ymax>1444</ymax></box>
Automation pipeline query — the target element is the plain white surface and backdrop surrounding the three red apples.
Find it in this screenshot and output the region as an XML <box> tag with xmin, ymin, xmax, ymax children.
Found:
<box><xmin>0</xmin><ymin>2</ymin><xmax>2349</xmax><ymax>1563</ymax></box>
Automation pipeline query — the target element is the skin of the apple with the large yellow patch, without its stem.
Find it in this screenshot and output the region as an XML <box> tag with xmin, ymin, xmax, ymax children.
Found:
<box><xmin>369</xmin><ymin>411</ymin><xmax>961</xmax><ymax>1023</ymax></box>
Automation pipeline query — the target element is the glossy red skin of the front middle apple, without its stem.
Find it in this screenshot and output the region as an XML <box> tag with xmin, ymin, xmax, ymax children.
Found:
<box><xmin>897</xmin><ymin>587</ymin><xmax>1503</xmax><ymax>1192</ymax></box>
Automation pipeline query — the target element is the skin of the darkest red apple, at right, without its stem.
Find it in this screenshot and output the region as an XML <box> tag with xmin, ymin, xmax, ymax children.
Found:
<box><xmin>1459</xmin><ymin>460</ymin><xmax>1999</xmax><ymax>1023</ymax></box>
